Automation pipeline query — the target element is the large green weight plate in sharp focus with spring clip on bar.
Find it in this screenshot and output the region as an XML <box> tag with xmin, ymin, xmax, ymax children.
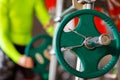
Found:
<box><xmin>54</xmin><ymin>9</ymin><xmax>120</xmax><ymax>78</ymax></box>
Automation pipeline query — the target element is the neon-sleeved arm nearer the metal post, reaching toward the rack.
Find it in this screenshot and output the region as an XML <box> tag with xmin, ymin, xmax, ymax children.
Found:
<box><xmin>35</xmin><ymin>0</ymin><xmax>54</xmax><ymax>36</ymax></box>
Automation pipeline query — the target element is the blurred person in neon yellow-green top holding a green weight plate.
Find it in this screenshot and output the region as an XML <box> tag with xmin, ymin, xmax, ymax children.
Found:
<box><xmin>0</xmin><ymin>0</ymin><xmax>54</xmax><ymax>80</ymax></box>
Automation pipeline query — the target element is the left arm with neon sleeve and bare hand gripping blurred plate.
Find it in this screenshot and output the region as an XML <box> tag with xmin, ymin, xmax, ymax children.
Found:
<box><xmin>0</xmin><ymin>0</ymin><xmax>33</xmax><ymax>68</ymax></box>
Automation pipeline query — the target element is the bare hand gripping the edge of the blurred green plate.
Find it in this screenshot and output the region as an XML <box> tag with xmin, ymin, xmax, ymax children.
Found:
<box><xmin>18</xmin><ymin>55</ymin><xmax>34</xmax><ymax>68</ymax></box>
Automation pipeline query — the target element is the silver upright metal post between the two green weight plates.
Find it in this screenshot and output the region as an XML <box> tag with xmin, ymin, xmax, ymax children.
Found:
<box><xmin>49</xmin><ymin>0</ymin><xmax>63</xmax><ymax>80</ymax></box>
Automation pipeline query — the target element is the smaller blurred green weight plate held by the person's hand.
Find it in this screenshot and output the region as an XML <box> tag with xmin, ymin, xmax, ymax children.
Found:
<box><xmin>25</xmin><ymin>34</ymin><xmax>52</xmax><ymax>80</ymax></box>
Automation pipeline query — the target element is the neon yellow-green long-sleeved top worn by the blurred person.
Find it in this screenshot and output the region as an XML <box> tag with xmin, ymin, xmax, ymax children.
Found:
<box><xmin>0</xmin><ymin>0</ymin><xmax>53</xmax><ymax>63</ymax></box>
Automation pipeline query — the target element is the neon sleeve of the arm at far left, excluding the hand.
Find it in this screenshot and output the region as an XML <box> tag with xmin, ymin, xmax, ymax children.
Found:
<box><xmin>0</xmin><ymin>2</ymin><xmax>21</xmax><ymax>63</ymax></box>
